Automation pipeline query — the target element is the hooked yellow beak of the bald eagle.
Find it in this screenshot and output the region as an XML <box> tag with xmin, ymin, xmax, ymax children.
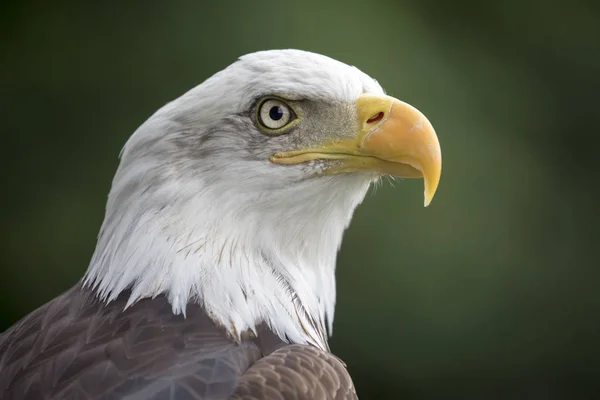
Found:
<box><xmin>271</xmin><ymin>95</ymin><xmax>442</xmax><ymax>207</ymax></box>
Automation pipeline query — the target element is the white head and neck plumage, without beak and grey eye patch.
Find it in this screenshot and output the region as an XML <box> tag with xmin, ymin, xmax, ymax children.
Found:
<box><xmin>85</xmin><ymin>50</ymin><xmax>383</xmax><ymax>349</ymax></box>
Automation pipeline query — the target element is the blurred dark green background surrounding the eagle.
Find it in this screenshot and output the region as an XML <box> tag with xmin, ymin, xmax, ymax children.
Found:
<box><xmin>0</xmin><ymin>0</ymin><xmax>600</xmax><ymax>400</ymax></box>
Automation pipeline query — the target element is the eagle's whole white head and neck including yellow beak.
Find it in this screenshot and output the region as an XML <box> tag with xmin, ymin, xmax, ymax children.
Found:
<box><xmin>85</xmin><ymin>50</ymin><xmax>441</xmax><ymax>348</ymax></box>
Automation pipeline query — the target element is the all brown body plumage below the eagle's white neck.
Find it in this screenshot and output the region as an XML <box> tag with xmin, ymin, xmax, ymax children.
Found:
<box><xmin>0</xmin><ymin>285</ymin><xmax>356</xmax><ymax>400</ymax></box>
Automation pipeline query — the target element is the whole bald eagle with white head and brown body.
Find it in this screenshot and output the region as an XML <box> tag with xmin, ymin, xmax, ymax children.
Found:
<box><xmin>0</xmin><ymin>50</ymin><xmax>441</xmax><ymax>400</ymax></box>
